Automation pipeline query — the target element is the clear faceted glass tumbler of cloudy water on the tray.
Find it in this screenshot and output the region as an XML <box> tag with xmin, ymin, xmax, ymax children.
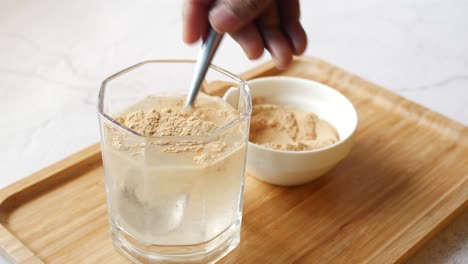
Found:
<box><xmin>98</xmin><ymin>60</ymin><xmax>252</xmax><ymax>263</ymax></box>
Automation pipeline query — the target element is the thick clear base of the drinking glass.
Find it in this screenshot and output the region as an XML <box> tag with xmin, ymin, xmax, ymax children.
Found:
<box><xmin>111</xmin><ymin>219</ymin><xmax>241</xmax><ymax>264</ymax></box>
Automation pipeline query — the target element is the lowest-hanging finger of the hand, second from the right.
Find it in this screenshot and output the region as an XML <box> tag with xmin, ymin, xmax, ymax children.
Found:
<box><xmin>258</xmin><ymin>2</ymin><xmax>292</xmax><ymax>69</ymax></box>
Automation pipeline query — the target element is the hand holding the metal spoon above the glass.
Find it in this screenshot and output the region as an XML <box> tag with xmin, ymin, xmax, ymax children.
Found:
<box><xmin>183</xmin><ymin>0</ymin><xmax>307</xmax><ymax>68</ymax></box>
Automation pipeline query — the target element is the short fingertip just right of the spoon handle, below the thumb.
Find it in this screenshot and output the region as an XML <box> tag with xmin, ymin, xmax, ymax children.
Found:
<box><xmin>231</xmin><ymin>23</ymin><xmax>265</xmax><ymax>60</ymax></box>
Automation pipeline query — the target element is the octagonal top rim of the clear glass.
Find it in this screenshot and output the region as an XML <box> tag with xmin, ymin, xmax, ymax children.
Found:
<box><xmin>97</xmin><ymin>59</ymin><xmax>252</xmax><ymax>141</ymax></box>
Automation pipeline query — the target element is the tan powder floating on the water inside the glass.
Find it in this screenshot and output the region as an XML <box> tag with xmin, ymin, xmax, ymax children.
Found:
<box><xmin>108</xmin><ymin>94</ymin><xmax>241</xmax><ymax>165</ymax></box>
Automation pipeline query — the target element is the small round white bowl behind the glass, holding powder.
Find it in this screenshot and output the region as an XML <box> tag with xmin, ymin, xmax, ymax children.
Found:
<box><xmin>243</xmin><ymin>77</ymin><xmax>358</xmax><ymax>186</ymax></box>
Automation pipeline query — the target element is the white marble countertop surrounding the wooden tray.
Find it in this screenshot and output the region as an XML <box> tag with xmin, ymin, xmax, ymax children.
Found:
<box><xmin>0</xmin><ymin>0</ymin><xmax>468</xmax><ymax>264</ymax></box>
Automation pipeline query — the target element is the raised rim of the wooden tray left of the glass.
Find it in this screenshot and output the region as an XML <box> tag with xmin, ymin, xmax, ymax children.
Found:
<box><xmin>0</xmin><ymin>144</ymin><xmax>101</xmax><ymax>208</ymax></box>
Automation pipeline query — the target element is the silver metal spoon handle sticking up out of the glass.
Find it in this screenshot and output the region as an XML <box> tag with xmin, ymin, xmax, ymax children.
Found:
<box><xmin>185</xmin><ymin>28</ymin><xmax>224</xmax><ymax>109</ymax></box>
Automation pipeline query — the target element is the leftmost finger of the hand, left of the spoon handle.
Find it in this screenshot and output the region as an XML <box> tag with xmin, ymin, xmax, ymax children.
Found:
<box><xmin>182</xmin><ymin>0</ymin><xmax>214</xmax><ymax>44</ymax></box>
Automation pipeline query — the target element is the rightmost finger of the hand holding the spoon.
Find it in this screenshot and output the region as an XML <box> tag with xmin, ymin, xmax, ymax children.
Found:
<box><xmin>278</xmin><ymin>0</ymin><xmax>307</xmax><ymax>55</ymax></box>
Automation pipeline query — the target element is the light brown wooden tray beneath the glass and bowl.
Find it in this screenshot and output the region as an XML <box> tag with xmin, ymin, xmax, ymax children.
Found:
<box><xmin>0</xmin><ymin>58</ymin><xmax>468</xmax><ymax>263</ymax></box>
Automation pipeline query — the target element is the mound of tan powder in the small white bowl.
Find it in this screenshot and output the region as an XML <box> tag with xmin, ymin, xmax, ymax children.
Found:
<box><xmin>250</xmin><ymin>100</ymin><xmax>339</xmax><ymax>151</ymax></box>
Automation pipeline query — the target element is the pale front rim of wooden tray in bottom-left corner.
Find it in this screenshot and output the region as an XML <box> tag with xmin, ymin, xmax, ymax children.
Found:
<box><xmin>0</xmin><ymin>225</ymin><xmax>44</xmax><ymax>264</ymax></box>
